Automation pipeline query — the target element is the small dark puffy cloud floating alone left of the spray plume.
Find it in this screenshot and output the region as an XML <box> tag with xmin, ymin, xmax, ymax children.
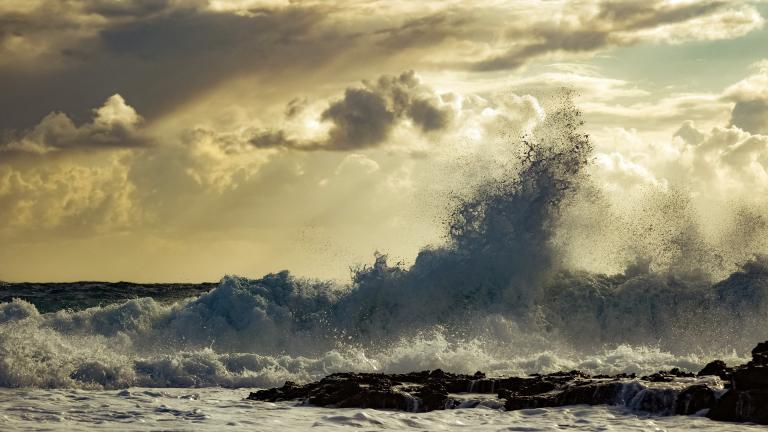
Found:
<box><xmin>250</xmin><ymin>71</ymin><xmax>452</xmax><ymax>151</ymax></box>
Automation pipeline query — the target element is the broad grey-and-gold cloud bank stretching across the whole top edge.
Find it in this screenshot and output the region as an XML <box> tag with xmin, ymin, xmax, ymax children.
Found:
<box><xmin>0</xmin><ymin>0</ymin><xmax>763</xmax><ymax>129</ymax></box>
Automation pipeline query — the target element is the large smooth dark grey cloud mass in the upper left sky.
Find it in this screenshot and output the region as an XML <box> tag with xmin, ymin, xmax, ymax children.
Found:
<box><xmin>0</xmin><ymin>1</ymin><xmax>344</xmax><ymax>129</ymax></box>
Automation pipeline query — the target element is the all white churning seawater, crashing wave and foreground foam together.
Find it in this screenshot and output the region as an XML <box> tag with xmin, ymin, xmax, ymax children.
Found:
<box><xmin>0</xmin><ymin>98</ymin><xmax>768</xmax><ymax>430</ymax></box>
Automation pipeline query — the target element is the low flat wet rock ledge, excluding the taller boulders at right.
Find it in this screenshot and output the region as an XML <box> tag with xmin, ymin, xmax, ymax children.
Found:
<box><xmin>248</xmin><ymin>369</ymin><xmax>700</xmax><ymax>414</ymax></box>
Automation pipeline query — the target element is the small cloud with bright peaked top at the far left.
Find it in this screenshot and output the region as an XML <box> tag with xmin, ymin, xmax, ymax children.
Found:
<box><xmin>0</xmin><ymin>94</ymin><xmax>147</xmax><ymax>157</ymax></box>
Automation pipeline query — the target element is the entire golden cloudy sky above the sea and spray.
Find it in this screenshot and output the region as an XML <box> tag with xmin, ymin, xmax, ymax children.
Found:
<box><xmin>0</xmin><ymin>0</ymin><xmax>768</xmax><ymax>282</ymax></box>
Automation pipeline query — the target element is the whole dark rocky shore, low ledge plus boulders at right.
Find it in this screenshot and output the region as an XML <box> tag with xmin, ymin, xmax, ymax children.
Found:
<box><xmin>248</xmin><ymin>342</ymin><xmax>768</xmax><ymax>424</ymax></box>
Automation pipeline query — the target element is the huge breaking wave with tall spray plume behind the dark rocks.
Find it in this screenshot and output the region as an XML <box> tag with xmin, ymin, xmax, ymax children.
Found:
<box><xmin>0</xmin><ymin>98</ymin><xmax>768</xmax><ymax>388</ymax></box>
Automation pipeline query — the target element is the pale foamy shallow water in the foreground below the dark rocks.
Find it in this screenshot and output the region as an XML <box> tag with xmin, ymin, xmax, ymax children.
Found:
<box><xmin>0</xmin><ymin>388</ymin><xmax>764</xmax><ymax>432</ymax></box>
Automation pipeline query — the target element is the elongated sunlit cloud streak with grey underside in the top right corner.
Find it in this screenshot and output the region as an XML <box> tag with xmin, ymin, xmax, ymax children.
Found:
<box><xmin>467</xmin><ymin>0</ymin><xmax>764</xmax><ymax>71</ymax></box>
